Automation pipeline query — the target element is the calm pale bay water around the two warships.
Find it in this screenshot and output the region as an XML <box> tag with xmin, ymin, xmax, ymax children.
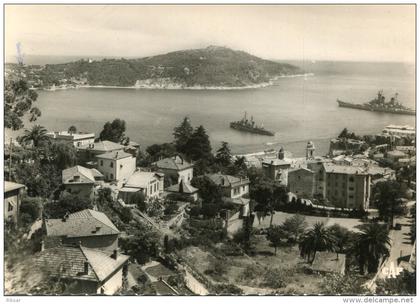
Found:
<box><xmin>13</xmin><ymin>61</ymin><xmax>416</xmax><ymax>157</ymax></box>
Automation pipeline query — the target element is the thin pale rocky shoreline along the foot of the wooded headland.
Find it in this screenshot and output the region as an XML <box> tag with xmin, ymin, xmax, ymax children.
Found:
<box><xmin>40</xmin><ymin>73</ymin><xmax>315</xmax><ymax>92</ymax></box>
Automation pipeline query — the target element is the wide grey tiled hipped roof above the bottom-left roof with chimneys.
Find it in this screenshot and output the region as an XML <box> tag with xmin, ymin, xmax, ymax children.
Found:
<box><xmin>45</xmin><ymin>209</ymin><xmax>120</xmax><ymax>237</ymax></box>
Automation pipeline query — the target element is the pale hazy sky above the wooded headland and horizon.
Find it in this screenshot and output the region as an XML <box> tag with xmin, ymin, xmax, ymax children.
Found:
<box><xmin>5</xmin><ymin>5</ymin><xmax>415</xmax><ymax>63</ymax></box>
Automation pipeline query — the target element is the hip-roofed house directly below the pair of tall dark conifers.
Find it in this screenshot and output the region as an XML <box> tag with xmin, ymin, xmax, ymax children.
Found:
<box><xmin>153</xmin><ymin>155</ymin><xmax>194</xmax><ymax>184</ymax></box>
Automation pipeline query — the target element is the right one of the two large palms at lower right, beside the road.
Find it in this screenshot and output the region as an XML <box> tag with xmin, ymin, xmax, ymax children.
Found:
<box><xmin>354</xmin><ymin>223</ymin><xmax>390</xmax><ymax>274</ymax></box>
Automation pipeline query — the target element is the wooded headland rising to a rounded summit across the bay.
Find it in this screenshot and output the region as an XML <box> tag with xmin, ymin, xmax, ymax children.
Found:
<box><xmin>8</xmin><ymin>46</ymin><xmax>304</xmax><ymax>88</ymax></box>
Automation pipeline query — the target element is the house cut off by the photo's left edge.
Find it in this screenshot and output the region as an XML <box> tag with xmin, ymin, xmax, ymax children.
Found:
<box><xmin>4</xmin><ymin>181</ymin><xmax>25</xmax><ymax>224</ymax></box>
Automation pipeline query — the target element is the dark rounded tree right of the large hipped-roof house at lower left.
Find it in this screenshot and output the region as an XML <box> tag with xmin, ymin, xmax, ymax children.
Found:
<box><xmin>120</xmin><ymin>223</ymin><xmax>161</xmax><ymax>264</ymax></box>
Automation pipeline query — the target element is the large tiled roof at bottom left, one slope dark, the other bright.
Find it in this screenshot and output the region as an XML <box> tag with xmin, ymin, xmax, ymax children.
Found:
<box><xmin>35</xmin><ymin>246</ymin><xmax>129</xmax><ymax>282</ymax></box>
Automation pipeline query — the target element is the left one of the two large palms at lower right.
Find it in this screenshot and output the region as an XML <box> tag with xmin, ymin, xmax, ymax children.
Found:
<box><xmin>299</xmin><ymin>222</ymin><xmax>336</xmax><ymax>263</ymax></box>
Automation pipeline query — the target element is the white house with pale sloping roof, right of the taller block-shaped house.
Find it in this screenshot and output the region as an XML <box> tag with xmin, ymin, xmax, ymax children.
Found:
<box><xmin>118</xmin><ymin>171</ymin><xmax>164</xmax><ymax>203</ymax></box>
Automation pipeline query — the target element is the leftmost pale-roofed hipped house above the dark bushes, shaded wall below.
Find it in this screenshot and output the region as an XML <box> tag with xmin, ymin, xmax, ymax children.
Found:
<box><xmin>62</xmin><ymin>166</ymin><xmax>104</xmax><ymax>199</ymax></box>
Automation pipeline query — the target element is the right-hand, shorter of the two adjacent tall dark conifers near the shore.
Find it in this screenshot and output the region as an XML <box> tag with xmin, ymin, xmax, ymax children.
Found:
<box><xmin>186</xmin><ymin>126</ymin><xmax>213</xmax><ymax>161</ymax></box>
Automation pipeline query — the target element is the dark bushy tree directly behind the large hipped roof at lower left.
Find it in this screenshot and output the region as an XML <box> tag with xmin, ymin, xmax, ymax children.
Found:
<box><xmin>44</xmin><ymin>192</ymin><xmax>93</xmax><ymax>218</ymax></box>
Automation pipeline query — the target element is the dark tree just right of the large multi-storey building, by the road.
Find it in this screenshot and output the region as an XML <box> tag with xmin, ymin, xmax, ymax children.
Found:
<box><xmin>373</xmin><ymin>180</ymin><xmax>403</xmax><ymax>225</ymax></box>
